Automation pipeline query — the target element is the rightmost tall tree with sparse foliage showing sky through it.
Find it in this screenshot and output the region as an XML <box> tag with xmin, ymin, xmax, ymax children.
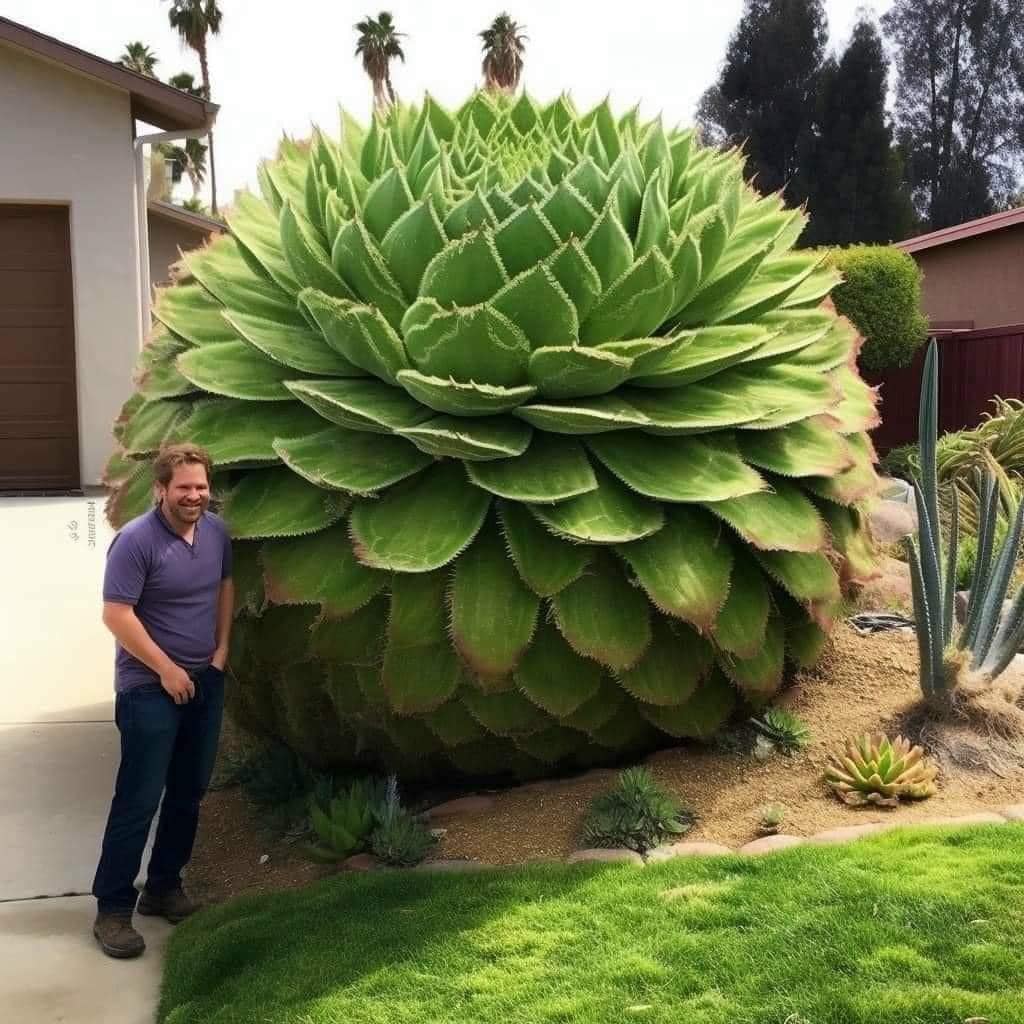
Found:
<box><xmin>882</xmin><ymin>0</ymin><xmax>1024</xmax><ymax>229</ymax></box>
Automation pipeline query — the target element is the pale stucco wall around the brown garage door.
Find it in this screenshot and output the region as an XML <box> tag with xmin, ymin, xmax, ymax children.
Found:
<box><xmin>0</xmin><ymin>45</ymin><xmax>139</xmax><ymax>485</ymax></box>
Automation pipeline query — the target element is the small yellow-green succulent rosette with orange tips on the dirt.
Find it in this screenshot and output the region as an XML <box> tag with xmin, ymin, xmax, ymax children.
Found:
<box><xmin>825</xmin><ymin>733</ymin><xmax>938</xmax><ymax>807</ymax></box>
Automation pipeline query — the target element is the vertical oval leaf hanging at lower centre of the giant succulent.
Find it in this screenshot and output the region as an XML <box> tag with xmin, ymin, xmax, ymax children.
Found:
<box><xmin>450</xmin><ymin>525</ymin><xmax>541</xmax><ymax>676</ymax></box>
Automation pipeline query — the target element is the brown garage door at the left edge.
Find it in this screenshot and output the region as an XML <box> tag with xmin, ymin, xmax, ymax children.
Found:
<box><xmin>0</xmin><ymin>204</ymin><xmax>79</xmax><ymax>490</ymax></box>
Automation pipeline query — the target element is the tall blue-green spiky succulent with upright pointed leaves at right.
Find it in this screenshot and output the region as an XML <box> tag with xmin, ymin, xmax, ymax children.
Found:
<box><xmin>906</xmin><ymin>341</ymin><xmax>1024</xmax><ymax>697</ymax></box>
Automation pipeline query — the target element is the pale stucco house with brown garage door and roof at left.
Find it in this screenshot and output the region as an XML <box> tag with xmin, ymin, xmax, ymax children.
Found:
<box><xmin>0</xmin><ymin>17</ymin><xmax>219</xmax><ymax>494</ymax></box>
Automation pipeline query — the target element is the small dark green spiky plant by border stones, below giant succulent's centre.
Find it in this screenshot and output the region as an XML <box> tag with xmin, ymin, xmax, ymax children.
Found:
<box><xmin>582</xmin><ymin>768</ymin><xmax>694</xmax><ymax>853</ymax></box>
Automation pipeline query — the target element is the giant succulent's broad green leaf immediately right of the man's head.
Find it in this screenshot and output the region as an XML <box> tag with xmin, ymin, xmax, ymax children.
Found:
<box><xmin>221</xmin><ymin>467</ymin><xmax>346</xmax><ymax>540</ymax></box>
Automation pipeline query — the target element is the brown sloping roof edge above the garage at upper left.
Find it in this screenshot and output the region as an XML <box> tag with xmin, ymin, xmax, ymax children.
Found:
<box><xmin>0</xmin><ymin>17</ymin><xmax>219</xmax><ymax>131</ymax></box>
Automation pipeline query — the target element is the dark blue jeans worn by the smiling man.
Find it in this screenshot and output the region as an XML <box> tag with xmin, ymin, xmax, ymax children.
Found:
<box><xmin>92</xmin><ymin>666</ymin><xmax>224</xmax><ymax>913</ymax></box>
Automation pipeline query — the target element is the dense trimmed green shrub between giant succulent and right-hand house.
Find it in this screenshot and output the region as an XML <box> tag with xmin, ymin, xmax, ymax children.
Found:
<box><xmin>829</xmin><ymin>246</ymin><xmax>928</xmax><ymax>371</ymax></box>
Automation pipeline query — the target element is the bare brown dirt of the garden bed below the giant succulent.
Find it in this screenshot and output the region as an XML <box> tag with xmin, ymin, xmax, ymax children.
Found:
<box><xmin>189</xmin><ymin>626</ymin><xmax>1024</xmax><ymax>899</ymax></box>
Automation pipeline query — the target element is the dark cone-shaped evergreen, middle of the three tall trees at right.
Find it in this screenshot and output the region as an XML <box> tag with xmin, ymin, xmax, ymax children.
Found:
<box><xmin>802</xmin><ymin>19</ymin><xmax>915</xmax><ymax>245</ymax></box>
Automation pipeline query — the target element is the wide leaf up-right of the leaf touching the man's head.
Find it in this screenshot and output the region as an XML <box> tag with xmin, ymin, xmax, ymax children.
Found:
<box><xmin>273</xmin><ymin>423</ymin><xmax>432</xmax><ymax>495</ymax></box>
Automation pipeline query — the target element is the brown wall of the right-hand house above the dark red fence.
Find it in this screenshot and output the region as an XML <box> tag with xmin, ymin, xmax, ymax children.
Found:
<box><xmin>911</xmin><ymin>224</ymin><xmax>1024</xmax><ymax>328</ymax></box>
